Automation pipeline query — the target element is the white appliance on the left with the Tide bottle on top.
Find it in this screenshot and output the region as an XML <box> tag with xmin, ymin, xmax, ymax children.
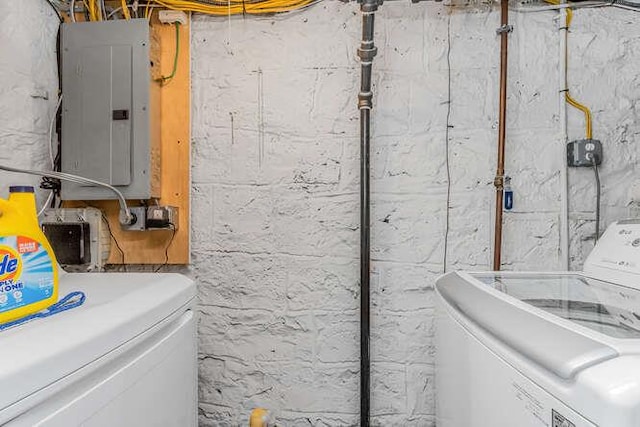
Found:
<box><xmin>0</xmin><ymin>273</ymin><xmax>197</xmax><ymax>427</ymax></box>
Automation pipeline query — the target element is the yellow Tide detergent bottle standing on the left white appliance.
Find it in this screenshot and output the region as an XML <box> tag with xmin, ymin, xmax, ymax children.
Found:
<box><xmin>0</xmin><ymin>186</ymin><xmax>58</xmax><ymax>324</ymax></box>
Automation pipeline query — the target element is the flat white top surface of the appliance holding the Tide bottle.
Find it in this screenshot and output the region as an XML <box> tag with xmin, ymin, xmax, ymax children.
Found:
<box><xmin>0</xmin><ymin>273</ymin><xmax>196</xmax><ymax>410</ymax></box>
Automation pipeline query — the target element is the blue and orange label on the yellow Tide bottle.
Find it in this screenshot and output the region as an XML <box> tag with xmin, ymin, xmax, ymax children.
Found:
<box><xmin>0</xmin><ymin>236</ymin><xmax>54</xmax><ymax>313</ymax></box>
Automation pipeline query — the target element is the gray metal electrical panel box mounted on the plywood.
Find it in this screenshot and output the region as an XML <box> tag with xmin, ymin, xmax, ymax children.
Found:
<box><xmin>61</xmin><ymin>19</ymin><xmax>160</xmax><ymax>200</ymax></box>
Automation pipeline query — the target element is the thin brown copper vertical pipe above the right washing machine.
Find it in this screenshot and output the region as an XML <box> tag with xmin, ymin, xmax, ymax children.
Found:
<box><xmin>493</xmin><ymin>0</ymin><xmax>511</xmax><ymax>271</ymax></box>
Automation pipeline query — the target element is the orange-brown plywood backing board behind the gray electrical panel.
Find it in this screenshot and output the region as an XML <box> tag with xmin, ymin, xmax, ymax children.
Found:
<box><xmin>65</xmin><ymin>12</ymin><xmax>191</xmax><ymax>264</ymax></box>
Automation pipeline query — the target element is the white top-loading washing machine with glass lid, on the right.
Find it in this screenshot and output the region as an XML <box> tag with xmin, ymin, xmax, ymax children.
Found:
<box><xmin>436</xmin><ymin>221</ymin><xmax>640</xmax><ymax>427</ymax></box>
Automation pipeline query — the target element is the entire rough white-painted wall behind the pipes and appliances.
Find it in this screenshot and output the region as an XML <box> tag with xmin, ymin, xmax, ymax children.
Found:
<box><xmin>0</xmin><ymin>0</ymin><xmax>640</xmax><ymax>427</ymax></box>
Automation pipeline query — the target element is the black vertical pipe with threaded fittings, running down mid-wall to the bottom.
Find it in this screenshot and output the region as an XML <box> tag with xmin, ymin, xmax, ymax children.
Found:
<box><xmin>358</xmin><ymin>0</ymin><xmax>378</xmax><ymax>427</ymax></box>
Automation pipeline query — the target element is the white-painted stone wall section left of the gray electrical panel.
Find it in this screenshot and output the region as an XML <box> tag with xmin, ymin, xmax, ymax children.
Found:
<box><xmin>0</xmin><ymin>0</ymin><xmax>59</xmax><ymax>201</ymax></box>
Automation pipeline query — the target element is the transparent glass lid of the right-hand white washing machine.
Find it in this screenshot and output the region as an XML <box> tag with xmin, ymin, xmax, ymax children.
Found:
<box><xmin>471</xmin><ymin>272</ymin><xmax>640</xmax><ymax>339</ymax></box>
